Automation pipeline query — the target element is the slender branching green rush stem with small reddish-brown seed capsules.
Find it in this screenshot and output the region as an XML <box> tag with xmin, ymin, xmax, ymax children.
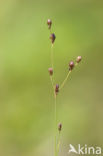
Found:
<box><xmin>47</xmin><ymin>19</ymin><xmax>82</xmax><ymax>156</ymax></box>
